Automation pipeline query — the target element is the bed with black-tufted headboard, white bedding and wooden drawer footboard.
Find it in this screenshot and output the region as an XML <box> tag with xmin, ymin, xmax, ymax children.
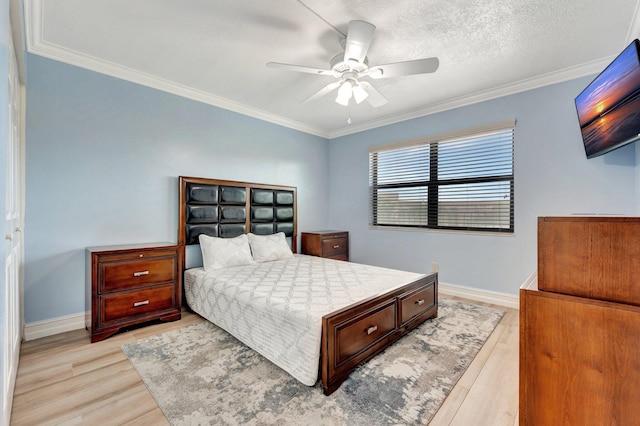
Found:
<box><xmin>178</xmin><ymin>177</ymin><xmax>438</xmax><ymax>395</ymax></box>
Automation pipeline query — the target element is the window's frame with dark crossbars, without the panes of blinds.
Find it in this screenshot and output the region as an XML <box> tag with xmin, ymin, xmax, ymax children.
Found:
<box><xmin>369</xmin><ymin>120</ymin><xmax>516</xmax><ymax>235</ymax></box>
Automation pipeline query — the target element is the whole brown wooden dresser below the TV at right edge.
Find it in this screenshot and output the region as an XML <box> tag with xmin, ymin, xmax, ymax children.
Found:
<box><xmin>519</xmin><ymin>217</ymin><xmax>640</xmax><ymax>426</ymax></box>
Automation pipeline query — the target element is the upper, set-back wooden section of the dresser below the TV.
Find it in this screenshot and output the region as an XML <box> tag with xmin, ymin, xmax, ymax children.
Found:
<box><xmin>538</xmin><ymin>216</ymin><xmax>640</xmax><ymax>306</ymax></box>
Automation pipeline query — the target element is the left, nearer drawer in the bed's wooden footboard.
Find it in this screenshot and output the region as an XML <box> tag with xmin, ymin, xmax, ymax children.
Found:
<box><xmin>336</xmin><ymin>299</ymin><xmax>396</xmax><ymax>366</ymax></box>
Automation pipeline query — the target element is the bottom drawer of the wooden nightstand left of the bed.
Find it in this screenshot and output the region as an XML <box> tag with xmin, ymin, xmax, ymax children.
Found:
<box><xmin>100</xmin><ymin>284</ymin><xmax>175</xmax><ymax>324</ymax></box>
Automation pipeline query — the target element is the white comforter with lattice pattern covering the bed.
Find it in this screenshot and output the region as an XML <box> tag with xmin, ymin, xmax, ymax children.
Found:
<box><xmin>184</xmin><ymin>255</ymin><xmax>424</xmax><ymax>386</ymax></box>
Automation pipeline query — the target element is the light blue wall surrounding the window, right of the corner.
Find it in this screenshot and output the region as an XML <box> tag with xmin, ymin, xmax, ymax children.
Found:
<box><xmin>329</xmin><ymin>78</ymin><xmax>638</xmax><ymax>294</ymax></box>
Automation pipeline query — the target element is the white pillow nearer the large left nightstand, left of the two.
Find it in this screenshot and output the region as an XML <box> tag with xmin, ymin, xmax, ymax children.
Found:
<box><xmin>198</xmin><ymin>234</ymin><xmax>255</xmax><ymax>271</ymax></box>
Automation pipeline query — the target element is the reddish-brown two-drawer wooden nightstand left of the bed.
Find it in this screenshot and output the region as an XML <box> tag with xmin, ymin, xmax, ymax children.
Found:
<box><xmin>85</xmin><ymin>243</ymin><xmax>182</xmax><ymax>342</ymax></box>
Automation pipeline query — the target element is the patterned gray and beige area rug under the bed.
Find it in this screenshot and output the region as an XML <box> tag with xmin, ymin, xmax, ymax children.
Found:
<box><xmin>122</xmin><ymin>298</ymin><xmax>504</xmax><ymax>426</ymax></box>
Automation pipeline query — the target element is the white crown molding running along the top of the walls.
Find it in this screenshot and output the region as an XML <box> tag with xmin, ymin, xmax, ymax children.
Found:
<box><xmin>24</xmin><ymin>0</ymin><xmax>616</xmax><ymax>139</ymax></box>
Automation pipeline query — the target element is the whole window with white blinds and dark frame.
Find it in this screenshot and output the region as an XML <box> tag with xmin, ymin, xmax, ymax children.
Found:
<box><xmin>369</xmin><ymin>121</ymin><xmax>515</xmax><ymax>233</ymax></box>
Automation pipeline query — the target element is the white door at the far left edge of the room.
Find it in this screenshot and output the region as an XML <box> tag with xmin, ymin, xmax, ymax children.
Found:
<box><xmin>0</xmin><ymin>30</ymin><xmax>22</xmax><ymax>424</ymax></box>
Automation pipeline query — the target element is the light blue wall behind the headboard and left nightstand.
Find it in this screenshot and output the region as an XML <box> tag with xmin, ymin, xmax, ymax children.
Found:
<box><xmin>24</xmin><ymin>55</ymin><xmax>328</xmax><ymax>324</ymax></box>
